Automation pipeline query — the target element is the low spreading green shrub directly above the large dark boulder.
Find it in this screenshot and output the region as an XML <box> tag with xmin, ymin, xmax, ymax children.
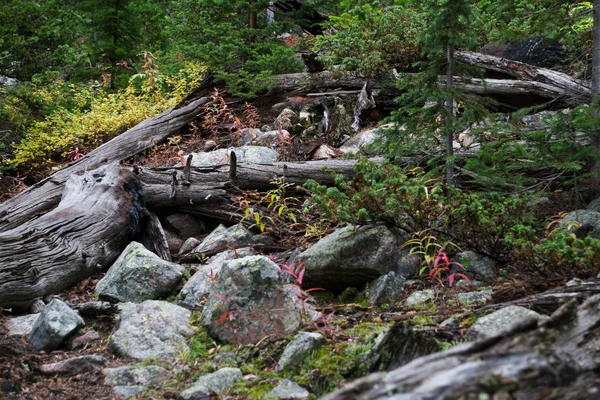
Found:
<box><xmin>306</xmin><ymin>161</ymin><xmax>533</xmax><ymax>260</ymax></box>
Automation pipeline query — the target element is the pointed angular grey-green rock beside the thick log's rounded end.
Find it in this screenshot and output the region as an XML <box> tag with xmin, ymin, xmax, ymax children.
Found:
<box><xmin>96</xmin><ymin>242</ymin><xmax>184</xmax><ymax>303</ymax></box>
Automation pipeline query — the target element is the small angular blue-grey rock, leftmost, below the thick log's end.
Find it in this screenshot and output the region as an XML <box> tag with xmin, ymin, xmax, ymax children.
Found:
<box><xmin>29</xmin><ymin>299</ymin><xmax>84</xmax><ymax>351</ymax></box>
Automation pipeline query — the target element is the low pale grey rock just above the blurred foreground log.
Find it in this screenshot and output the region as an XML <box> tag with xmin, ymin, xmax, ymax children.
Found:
<box><xmin>467</xmin><ymin>306</ymin><xmax>542</xmax><ymax>341</ymax></box>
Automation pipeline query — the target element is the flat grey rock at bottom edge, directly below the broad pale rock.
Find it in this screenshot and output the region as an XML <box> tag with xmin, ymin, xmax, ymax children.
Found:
<box><xmin>102</xmin><ymin>365</ymin><xmax>169</xmax><ymax>398</ymax></box>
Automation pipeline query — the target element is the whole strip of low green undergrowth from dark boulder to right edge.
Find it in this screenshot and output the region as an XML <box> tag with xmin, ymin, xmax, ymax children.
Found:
<box><xmin>305</xmin><ymin>160</ymin><xmax>600</xmax><ymax>276</ymax></box>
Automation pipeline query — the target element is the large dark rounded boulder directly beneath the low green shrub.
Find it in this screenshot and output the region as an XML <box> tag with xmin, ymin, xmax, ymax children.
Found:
<box><xmin>290</xmin><ymin>225</ymin><xmax>419</xmax><ymax>292</ymax></box>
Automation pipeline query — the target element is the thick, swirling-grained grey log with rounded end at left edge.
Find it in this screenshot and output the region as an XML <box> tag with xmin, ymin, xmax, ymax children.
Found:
<box><xmin>0</xmin><ymin>163</ymin><xmax>147</xmax><ymax>308</ymax></box>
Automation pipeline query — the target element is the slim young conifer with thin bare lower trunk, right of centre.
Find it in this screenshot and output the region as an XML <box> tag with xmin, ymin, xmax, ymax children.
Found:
<box><xmin>387</xmin><ymin>0</ymin><xmax>485</xmax><ymax>184</ymax></box>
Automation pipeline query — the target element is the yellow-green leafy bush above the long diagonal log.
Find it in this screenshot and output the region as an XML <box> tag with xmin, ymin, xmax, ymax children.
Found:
<box><xmin>8</xmin><ymin>63</ymin><xmax>205</xmax><ymax>169</ymax></box>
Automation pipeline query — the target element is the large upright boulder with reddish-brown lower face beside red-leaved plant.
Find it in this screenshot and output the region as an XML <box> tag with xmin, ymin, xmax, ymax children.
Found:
<box><xmin>202</xmin><ymin>256</ymin><xmax>312</xmax><ymax>344</ymax></box>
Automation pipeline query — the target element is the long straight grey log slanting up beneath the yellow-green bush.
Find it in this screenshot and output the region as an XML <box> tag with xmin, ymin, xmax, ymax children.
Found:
<box><xmin>0</xmin><ymin>97</ymin><xmax>208</xmax><ymax>232</ymax></box>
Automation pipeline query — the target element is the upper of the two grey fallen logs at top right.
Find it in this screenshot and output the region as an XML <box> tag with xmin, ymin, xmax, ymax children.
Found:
<box><xmin>455</xmin><ymin>51</ymin><xmax>592</xmax><ymax>104</ymax></box>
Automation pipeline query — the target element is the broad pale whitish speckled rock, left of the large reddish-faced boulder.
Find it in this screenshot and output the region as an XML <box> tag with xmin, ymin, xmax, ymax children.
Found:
<box><xmin>108</xmin><ymin>300</ymin><xmax>194</xmax><ymax>360</ymax></box>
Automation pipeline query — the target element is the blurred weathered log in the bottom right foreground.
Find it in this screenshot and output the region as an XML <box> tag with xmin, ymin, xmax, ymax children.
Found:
<box><xmin>323</xmin><ymin>295</ymin><xmax>600</xmax><ymax>400</ymax></box>
